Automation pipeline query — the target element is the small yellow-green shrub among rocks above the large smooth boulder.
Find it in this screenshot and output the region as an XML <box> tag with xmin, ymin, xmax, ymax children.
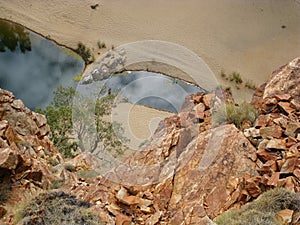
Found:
<box><xmin>213</xmin><ymin>102</ymin><xmax>258</xmax><ymax>129</ymax></box>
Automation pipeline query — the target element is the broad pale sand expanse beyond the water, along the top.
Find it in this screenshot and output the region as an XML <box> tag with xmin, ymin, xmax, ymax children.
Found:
<box><xmin>0</xmin><ymin>0</ymin><xmax>300</xmax><ymax>101</ymax></box>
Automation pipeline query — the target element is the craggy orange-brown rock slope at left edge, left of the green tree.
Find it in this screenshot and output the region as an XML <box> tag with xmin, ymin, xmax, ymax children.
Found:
<box><xmin>0</xmin><ymin>89</ymin><xmax>75</xmax><ymax>223</ymax></box>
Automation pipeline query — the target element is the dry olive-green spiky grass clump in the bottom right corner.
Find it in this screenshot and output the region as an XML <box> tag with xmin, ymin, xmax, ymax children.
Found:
<box><xmin>215</xmin><ymin>188</ymin><xmax>300</xmax><ymax>225</ymax></box>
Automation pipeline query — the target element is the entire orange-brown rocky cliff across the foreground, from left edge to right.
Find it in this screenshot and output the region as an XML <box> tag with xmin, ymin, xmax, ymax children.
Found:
<box><xmin>0</xmin><ymin>58</ymin><xmax>300</xmax><ymax>225</ymax></box>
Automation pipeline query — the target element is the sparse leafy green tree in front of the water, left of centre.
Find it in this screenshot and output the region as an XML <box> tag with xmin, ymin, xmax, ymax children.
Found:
<box><xmin>36</xmin><ymin>87</ymin><xmax>127</xmax><ymax>158</ymax></box>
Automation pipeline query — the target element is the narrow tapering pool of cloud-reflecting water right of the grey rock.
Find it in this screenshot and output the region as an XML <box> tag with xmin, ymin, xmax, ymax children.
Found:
<box><xmin>98</xmin><ymin>71</ymin><xmax>204</xmax><ymax>113</ymax></box>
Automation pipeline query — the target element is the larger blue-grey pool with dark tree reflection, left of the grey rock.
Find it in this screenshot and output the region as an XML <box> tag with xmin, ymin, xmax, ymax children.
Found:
<box><xmin>0</xmin><ymin>19</ymin><xmax>84</xmax><ymax>109</ymax></box>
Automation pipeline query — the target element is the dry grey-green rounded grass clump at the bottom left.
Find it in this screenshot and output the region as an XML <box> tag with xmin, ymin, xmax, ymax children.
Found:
<box><xmin>15</xmin><ymin>192</ymin><xmax>104</xmax><ymax>225</ymax></box>
